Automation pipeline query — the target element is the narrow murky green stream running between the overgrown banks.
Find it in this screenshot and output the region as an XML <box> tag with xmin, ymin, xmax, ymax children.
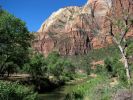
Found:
<box><xmin>39</xmin><ymin>77</ymin><xmax>89</xmax><ymax>100</ymax></box>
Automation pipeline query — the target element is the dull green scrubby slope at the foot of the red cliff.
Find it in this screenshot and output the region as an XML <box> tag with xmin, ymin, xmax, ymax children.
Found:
<box><xmin>68</xmin><ymin>45</ymin><xmax>120</xmax><ymax>69</ymax></box>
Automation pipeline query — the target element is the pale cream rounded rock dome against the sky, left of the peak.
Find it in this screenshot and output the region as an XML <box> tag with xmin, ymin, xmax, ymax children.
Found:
<box><xmin>38</xmin><ymin>6</ymin><xmax>81</xmax><ymax>32</ymax></box>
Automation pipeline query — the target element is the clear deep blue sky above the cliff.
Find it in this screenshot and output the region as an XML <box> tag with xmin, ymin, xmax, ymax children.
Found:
<box><xmin>0</xmin><ymin>0</ymin><xmax>87</xmax><ymax>32</ymax></box>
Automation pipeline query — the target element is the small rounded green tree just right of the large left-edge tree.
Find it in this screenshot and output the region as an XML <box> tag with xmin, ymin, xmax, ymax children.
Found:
<box><xmin>24</xmin><ymin>53</ymin><xmax>47</xmax><ymax>79</ymax></box>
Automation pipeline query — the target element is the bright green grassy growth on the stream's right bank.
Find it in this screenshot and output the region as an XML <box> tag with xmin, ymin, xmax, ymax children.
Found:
<box><xmin>65</xmin><ymin>75</ymin><xmax>125</xmax><ymax>100</ymax></box>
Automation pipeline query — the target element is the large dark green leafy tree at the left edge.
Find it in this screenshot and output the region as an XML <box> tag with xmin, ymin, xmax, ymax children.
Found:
<box><xmin>0</xmin><ymin>10</ymin><xmax>32</xmax><ymax>75</ymax></box>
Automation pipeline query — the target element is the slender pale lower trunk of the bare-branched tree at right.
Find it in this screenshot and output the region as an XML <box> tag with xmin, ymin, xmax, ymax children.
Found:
<box><xmin>118</xmin><ymin>45</ymin><xmax>131</xmax><ymax>82</ymax></box>
